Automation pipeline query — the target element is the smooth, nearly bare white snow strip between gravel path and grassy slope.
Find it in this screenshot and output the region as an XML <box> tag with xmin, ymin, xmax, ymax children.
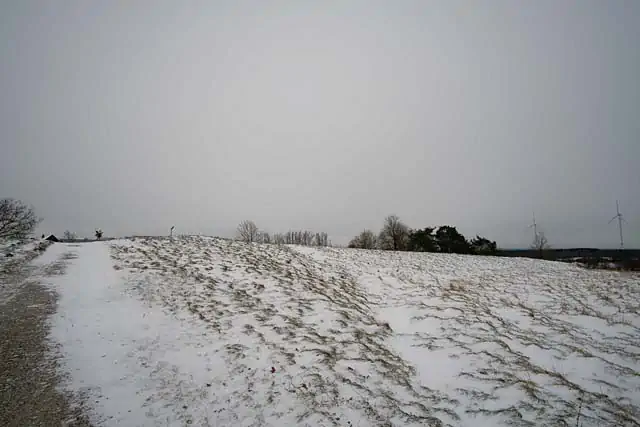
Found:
<box><xmin>43</xmin><ymin>242</ymin><xmax>224</xmax><ymax>426</ymax></box>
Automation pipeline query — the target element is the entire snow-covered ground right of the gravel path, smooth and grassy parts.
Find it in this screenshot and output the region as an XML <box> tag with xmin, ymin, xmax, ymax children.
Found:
<box><xmin>41</xmin><ymin>237</ymin><xmax>640</xmax><ymax>427</ymax></box>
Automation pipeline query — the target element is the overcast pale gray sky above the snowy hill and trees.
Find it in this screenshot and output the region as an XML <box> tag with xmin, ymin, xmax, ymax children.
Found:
<box><xmin>0</xmin><ymin>0</ymin><xmax>640</xmax><ymax>247</ymax></box>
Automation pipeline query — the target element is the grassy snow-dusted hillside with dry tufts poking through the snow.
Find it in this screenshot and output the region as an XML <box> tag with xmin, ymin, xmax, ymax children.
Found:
<box><xmin>113</xmin><ymin>237</ymin><xmax>640</xmax><ymax>426</ymax></box>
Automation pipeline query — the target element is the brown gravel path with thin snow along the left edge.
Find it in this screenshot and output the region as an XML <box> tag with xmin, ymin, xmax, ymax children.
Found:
<box><xmin>0</xmin><ymin>247</ymin><xmax>90</xmax><ymax>427</ymax></box>
